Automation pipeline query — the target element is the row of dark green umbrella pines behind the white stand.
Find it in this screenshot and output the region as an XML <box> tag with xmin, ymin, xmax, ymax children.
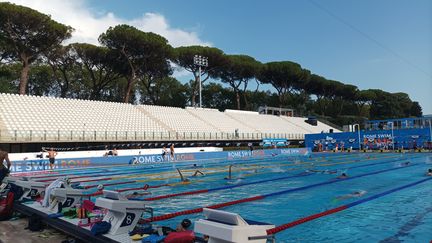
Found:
<box><xmin>0</xmin><ymin>2</ymin><xmax>422</xmax><ymax>125</ymax></box>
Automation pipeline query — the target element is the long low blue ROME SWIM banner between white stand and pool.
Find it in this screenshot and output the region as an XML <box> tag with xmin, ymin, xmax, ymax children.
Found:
<box><xmin>11</xmin><ymin>148</ymin><xmax>311</xmax><ymax>172</ymax></box>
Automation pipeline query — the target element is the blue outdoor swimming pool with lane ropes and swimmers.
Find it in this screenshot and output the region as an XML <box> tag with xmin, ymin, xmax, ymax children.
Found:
<box><xmin>13</xmin><ymin>153</ymin><xmax>432</xmax><ymax>242</ymax></box>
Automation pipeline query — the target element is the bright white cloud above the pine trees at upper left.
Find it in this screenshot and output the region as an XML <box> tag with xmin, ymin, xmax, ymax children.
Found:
<box><xmin>2</xmin><ymin>0</ymin><xmax>211</xmax><ymax>47</ymax></box>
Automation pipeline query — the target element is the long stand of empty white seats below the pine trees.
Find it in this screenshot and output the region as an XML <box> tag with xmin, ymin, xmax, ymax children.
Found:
<box><xmin>0</xmin><ymin>94</ymin><xmax>338</xmax><ymax>142</ymax></box>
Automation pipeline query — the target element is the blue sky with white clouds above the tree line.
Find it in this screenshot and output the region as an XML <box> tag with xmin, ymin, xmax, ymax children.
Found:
<box><xmin>3</xmin><ymin>0</ymin><xmax>432</xmax><ymax>114</ymax></box>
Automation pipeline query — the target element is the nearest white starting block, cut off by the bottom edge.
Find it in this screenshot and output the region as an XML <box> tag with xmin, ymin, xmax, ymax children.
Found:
<box><xmin>194</xmin><ymin>208</ymin><xmax>275</xmax><ymax>243</ymax></box>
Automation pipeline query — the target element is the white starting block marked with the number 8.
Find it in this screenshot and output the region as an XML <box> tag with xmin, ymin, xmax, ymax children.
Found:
<box><xmin>96</xmin><ymin>190</ymin><xmax>153</xmax><ymax>235</ymax></box>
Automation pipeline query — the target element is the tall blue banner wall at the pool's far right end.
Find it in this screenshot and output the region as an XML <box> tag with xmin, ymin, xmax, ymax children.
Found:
<box><xmin>305</xmin><ymin>128</ymin><xmax>430</xmax><ymax>149</ymax></box>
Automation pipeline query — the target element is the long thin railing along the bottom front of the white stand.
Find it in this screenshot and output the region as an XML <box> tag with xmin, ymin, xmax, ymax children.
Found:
<box><xmin>0</xmin><ymin>130</ymin><xmax>304</xmax><ymax>143</ymax></box>
